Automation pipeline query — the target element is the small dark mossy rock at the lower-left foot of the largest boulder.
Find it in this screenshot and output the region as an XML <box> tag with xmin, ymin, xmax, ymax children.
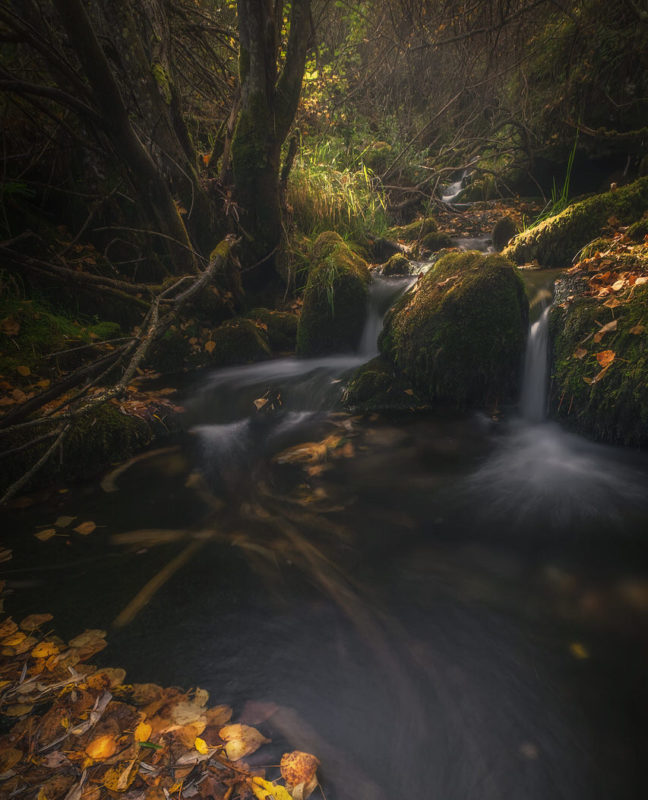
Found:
<box><xmin>342</xmin><ymin>356</ymin><xmax>425</xmax><ymax>413</ymax></box>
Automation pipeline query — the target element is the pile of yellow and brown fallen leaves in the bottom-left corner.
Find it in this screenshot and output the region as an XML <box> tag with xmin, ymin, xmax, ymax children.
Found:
<box><xmin>0</xmin><ymin>600</ymin><xmax>319</xmax><ymax>800</ymax></box>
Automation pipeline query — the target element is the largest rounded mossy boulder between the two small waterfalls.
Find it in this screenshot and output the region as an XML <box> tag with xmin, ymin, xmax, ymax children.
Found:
<box><xmin>379</xmin><ymin>251</ymin><xmax>528</xmax><ymax>406</ymax></box>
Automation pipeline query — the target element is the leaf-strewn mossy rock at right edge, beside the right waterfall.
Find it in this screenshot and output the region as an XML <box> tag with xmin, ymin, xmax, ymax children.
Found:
<box><xmin>549</xmin><ymin>286</ymin><xmax>648</xmax><ymax>447</ymax></box>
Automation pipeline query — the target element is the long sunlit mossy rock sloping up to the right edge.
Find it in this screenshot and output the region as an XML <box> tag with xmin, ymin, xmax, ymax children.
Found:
<box><xmin>503</xmin><ymin>178</ymin><xmax>648</xmax><ymax>267</ymax></box>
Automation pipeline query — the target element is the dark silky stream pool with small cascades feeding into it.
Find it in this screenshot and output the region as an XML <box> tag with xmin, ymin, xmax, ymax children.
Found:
<box><xmin>0</xmin><ymin>264</ymin><xmax>648</xmax><ymax>800</ymax></box>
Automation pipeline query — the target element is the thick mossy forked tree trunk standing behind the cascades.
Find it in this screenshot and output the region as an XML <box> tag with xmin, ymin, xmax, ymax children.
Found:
<box><xmin>232</xmin><ymin>0</ymin><xmax>311</xmax><ymax>287</ymax></box>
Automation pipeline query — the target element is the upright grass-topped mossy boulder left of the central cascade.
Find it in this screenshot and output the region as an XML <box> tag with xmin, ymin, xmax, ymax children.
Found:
<box><xmin>297</xmin><ymin>231</ymin><xmax>370</xmax><ymax>356</ymax></box>
